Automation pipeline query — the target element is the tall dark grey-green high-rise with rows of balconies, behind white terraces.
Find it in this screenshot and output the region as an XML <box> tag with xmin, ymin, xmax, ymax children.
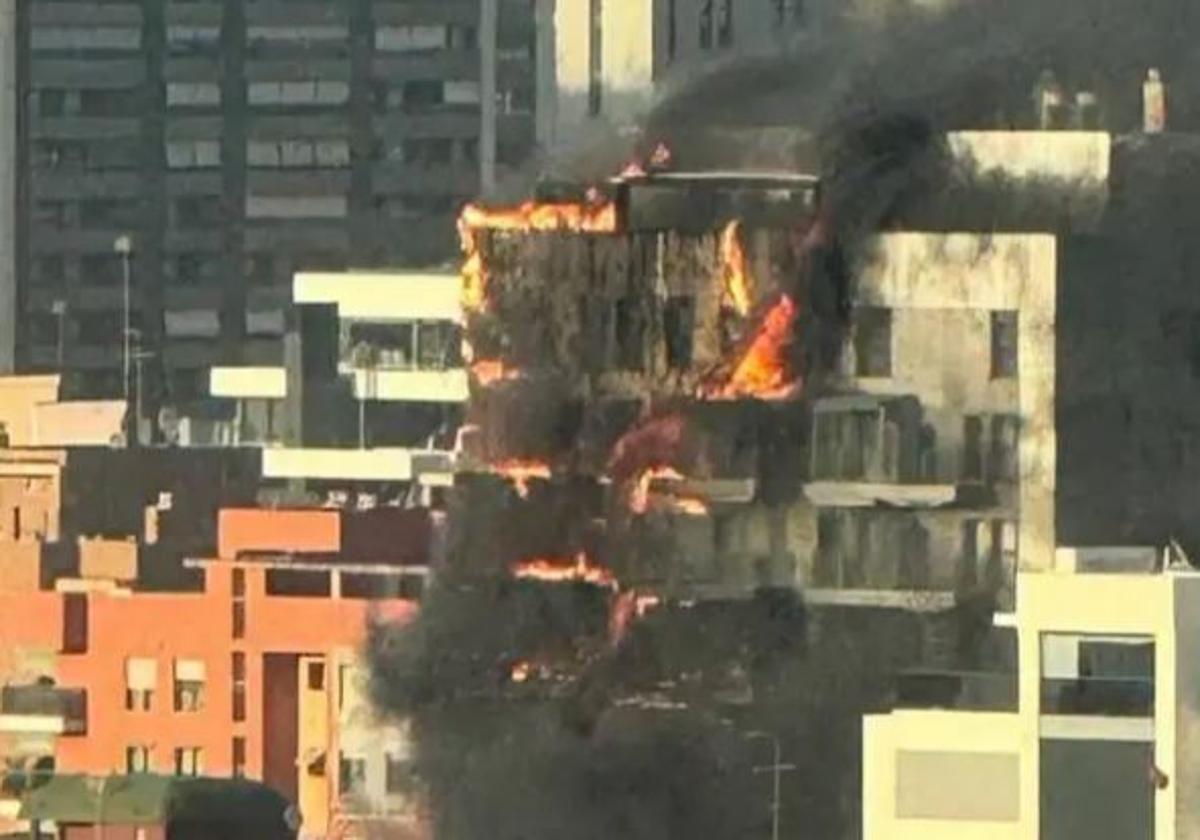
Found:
<box><xmin>14</xmin><ymin>0</ymin><xmax>535</xmax><ymax>414</ymax></box>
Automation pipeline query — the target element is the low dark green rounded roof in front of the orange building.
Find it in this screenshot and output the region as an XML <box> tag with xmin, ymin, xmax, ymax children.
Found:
<box><xmin>20</xmin><ymin>774</ymin><xmax>289</xmax><ymax>836</ymax></box>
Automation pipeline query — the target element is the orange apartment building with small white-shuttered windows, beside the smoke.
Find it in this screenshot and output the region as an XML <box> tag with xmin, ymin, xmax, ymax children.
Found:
<box><xmin>0</xmin><ymin>508</ymin><xmax>428</xmax><ymax>836</ymax></box>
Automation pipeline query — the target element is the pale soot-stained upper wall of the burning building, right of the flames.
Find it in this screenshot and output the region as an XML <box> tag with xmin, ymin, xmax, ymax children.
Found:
<box><xmin>847</xmin><ymin>233</ymin><xmax>1057</xmax><ymax>580</ymax></box>
